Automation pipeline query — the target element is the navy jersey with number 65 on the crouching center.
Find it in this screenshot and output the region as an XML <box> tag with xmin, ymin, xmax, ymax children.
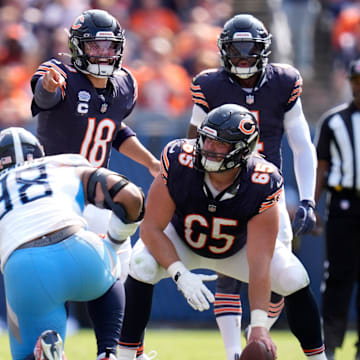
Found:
<box><xmin>161</xmin><ymin>139</ymin><xmax>283</xmax><ymax>259</ymax></box>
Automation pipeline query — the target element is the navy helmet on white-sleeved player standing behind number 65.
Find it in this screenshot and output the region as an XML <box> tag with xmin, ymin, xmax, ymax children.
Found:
<box><xmin>217</xmin><ymin>14</ymin><xmax>272</xmax><ymax>79</ymax></box>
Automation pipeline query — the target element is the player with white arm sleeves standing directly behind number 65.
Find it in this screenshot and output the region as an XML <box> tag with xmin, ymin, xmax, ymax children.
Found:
<box><xmin>188</xmin><ymin>14</ymin><xmax>316</xmax><ymax>360</ymax></box>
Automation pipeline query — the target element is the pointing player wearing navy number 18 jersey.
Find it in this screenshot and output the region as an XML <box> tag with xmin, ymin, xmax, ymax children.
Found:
<box><xmin>31</xmin><ymin>9</ymin><xmax>160</xmax><ymax>360</ymax></box>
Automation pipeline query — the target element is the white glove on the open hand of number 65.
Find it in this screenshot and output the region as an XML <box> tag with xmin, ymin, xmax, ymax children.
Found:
<box><xmin>167</xmin><ymin>261</ymin><xmax>217</xmax><ymax>311</ymax></box>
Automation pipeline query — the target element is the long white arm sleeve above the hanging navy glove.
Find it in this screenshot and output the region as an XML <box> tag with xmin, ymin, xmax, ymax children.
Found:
<box><xmin>284</xmin><ymin>98</ymin><xmax>317</xmax><ymax>201</ymax></box>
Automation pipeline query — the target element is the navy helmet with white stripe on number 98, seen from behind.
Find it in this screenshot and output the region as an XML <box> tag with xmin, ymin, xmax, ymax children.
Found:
<box><xmin>0</xmin><ymin>127</ymin><xmax>45</xmax><ymax>171</ymax></box>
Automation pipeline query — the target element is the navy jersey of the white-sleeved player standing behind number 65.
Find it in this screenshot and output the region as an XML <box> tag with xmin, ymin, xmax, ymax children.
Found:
<box><xmin>191</xmin><ymin>64</ymin><xmax>302</xmax><ymax>169</ymax></box>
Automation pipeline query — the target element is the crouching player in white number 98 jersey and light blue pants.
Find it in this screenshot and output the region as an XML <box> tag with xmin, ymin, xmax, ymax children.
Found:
<box><xmin>0</xmin><ymin>128</ymin><xmax>144</xmax><ymax>360</ymax></box>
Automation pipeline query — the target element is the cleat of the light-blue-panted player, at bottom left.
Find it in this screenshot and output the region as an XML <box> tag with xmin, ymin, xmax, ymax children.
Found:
<box><xmin>34</xmin><ymin>330</ymin><xmax>66</xmax><ymax>360</ymax></box>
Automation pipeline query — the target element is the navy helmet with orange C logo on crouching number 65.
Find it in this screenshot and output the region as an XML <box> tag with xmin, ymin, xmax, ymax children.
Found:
<box><xmin>194</xmin><ymin>104</ymin><xmax>259</xmax><ymax>172</ymax></box>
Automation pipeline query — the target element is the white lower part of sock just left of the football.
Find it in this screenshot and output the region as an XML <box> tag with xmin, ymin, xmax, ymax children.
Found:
<box><xmin>216</xmin><ymin>315</ymin><xmax>241</xmax><ymax>360</ymax></box>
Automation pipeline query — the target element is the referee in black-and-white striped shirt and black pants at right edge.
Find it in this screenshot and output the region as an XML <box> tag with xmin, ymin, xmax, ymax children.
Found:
<box><xmin>315</xmin><ymin>59</ymin><xmax>360</xmax><ymax>360</ymax></box>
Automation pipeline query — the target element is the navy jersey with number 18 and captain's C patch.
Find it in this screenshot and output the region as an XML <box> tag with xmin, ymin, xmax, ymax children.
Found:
<box><xmin>31</xmin><ymin>59</ymin><xmax>137</xmax><ymax>167</ymax></box>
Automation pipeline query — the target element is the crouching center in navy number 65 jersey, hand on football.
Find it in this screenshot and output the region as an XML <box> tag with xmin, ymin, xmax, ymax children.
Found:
<box><xmin>118</xmin><ymin>104</ymin><xmax>326</xmax><ymax>360</ymax></box>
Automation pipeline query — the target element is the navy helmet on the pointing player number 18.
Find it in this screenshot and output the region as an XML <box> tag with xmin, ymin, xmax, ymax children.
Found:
<box><xmin>69</xmin><ymin>9</ymin><xmax>125</xmax><ymax>77</ymax></box>
